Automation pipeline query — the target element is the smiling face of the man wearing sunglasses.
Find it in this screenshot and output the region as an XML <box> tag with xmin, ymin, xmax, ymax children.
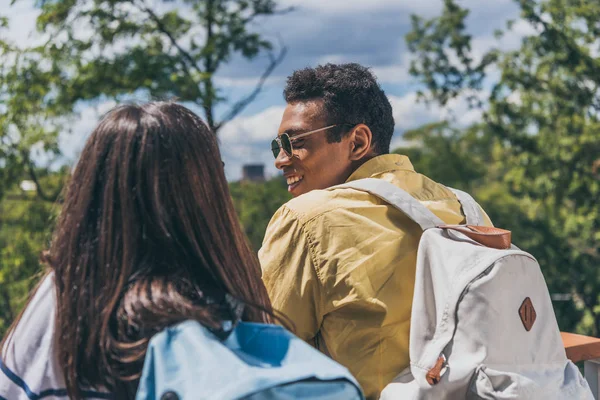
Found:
<box><xmin>275</xmin><ymin>100</ymin><xmax>352</xmax><ymax>197</ymax></box>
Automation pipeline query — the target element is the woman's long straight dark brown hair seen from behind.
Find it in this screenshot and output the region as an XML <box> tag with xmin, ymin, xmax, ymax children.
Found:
<box><xmin>2</xmin><ymin>102</ymin><xmax>272</xmax><ymax>399</ymax></box>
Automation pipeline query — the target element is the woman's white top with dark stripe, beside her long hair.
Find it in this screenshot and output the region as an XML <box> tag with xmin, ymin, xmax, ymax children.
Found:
<box><xmin>0</xmin><ymin>273</ymin><xmax>111</xmax><ymax>400</ymax></box>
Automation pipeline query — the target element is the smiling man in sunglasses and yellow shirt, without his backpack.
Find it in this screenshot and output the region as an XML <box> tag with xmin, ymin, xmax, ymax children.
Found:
<box><xmin>259</xmin><ymin>64</ymin><xmax>489</xmax><ymax>399</ymax></box>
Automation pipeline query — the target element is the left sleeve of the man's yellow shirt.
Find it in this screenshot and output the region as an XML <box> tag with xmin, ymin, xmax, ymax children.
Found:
<box><xmin>258</xmin><ymin>206</ymin><xmax>323</xmax><ymax>342</ymax></box>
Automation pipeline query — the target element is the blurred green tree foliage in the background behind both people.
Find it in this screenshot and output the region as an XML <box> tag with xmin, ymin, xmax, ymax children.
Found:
<box><xmin>0</xmin><ymin>0</ymin><xmax>600</xmax><ymax>336</ymax></box>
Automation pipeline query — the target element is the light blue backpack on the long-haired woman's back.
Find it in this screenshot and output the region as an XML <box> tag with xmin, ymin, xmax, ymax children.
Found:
<box><xmin>136</xmin><ymin>321</ymin><xmax>364</xmax><ymax>400</ymax></box>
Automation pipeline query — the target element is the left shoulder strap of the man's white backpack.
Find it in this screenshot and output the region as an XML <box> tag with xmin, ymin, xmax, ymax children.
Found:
<box><xmin>329</xmin><ymin>178</ymin><xmax>444</xmax><ymax>230</ymax></box>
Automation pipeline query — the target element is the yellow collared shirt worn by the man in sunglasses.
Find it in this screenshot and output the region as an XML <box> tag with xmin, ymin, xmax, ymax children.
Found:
<box><xmin>259</xmin><ymin>154</ymin><xmax>491</xmax><ymax>399</ymax></box>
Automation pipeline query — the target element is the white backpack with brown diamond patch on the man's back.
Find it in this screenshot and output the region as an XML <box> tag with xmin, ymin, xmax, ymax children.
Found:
<box><xmin>338</xmin><ymin>179</ymin><xmax>593</xmax><ymax>400</ymax></box>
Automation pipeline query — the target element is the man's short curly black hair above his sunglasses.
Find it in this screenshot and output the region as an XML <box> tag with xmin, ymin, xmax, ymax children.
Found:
<box><xmin>283</xmin><ymin>63</ymin><xmax>394</xmax><ymax>154</ymax></box>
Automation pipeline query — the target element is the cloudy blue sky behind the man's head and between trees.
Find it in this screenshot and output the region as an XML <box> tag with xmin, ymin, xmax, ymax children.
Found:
<box><xmin>0</xmin><ymin>0</ymin><xmax>528</xmax><ymax>180</ymax></box>
